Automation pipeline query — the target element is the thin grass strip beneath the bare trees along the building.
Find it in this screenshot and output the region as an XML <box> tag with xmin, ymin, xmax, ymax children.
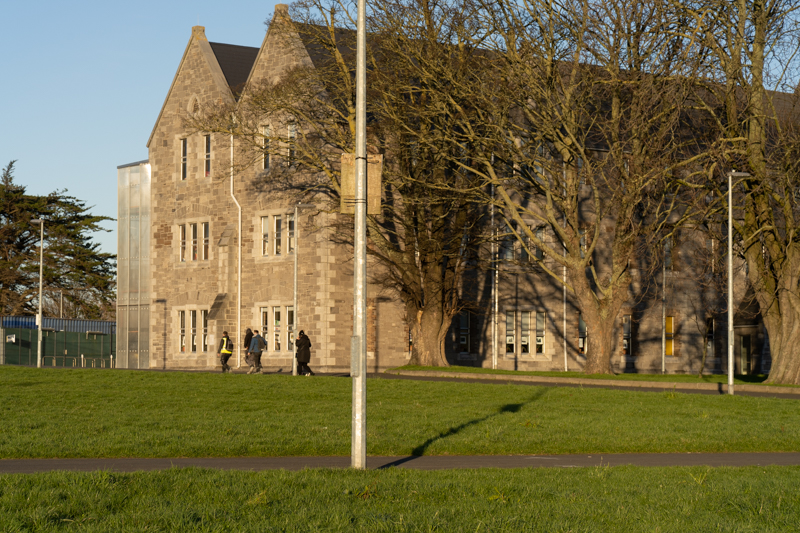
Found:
<box><xmin>390</xmin><ymin>365</ymin><xmax>795</xmax><ymax>387</ymax></box>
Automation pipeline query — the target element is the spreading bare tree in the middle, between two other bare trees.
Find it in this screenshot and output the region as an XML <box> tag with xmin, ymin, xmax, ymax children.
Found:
<box><xmin>418</xmin><ymin>0</ymin><xmax>696</xmax><ymax>373</ymax></box>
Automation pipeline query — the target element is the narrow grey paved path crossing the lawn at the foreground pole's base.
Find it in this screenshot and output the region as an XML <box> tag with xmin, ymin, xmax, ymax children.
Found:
<box><xmin>0</xmin><ymin>452</ymin><xmax>800</xmax><ymax>474</ymax></box>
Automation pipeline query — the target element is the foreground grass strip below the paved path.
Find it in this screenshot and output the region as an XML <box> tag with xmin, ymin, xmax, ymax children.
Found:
<box><xmin>0</xmin><ymin>467</ymin><xmax>800</xmax><ymax>533</ymax></box>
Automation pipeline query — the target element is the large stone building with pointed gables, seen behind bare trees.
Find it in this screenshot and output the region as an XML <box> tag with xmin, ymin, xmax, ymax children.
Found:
<box><xmin>118</xmin><ymin>5</ymin><xmax>764</xmax><ymax>372</ymax></box>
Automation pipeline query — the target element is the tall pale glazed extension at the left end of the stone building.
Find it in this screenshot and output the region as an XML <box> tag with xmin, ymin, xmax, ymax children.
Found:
<box><xmin>117</xmin><ymin>161</ymin><xmax>150</xmax><ymax>368</ymax></box>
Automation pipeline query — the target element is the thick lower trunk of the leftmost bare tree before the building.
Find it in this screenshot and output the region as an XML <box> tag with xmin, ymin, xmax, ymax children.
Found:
<box><xmin>406</xmin><ymin>305</ymin><xmax>452</xmax><ymax>366</ymax></box>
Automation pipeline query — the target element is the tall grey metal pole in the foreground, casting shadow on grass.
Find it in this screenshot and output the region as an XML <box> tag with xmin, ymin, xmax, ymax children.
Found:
<box><xmin>350</xmin><ymin>0</ymin><xmax>367</xmax><ymax>470</ymax></box>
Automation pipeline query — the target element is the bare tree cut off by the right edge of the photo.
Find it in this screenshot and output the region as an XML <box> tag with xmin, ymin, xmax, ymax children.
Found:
<box><xmin>680</xmin><ymin>0</ymin><xmax>800</xmax><ymax>384</ymax></box>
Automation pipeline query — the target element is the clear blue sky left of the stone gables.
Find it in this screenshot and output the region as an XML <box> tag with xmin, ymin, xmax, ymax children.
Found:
<box><xmin>0</xmin><ymin>0</ymin><xmax>288</xmax><ymax>253</ymax></box>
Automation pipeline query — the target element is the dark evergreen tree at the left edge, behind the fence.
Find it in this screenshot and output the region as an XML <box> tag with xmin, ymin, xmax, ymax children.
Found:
<box><xmin>0</xmin><ymin>161</ymin><xmax>116</xmax><ymax>320</ymax></box>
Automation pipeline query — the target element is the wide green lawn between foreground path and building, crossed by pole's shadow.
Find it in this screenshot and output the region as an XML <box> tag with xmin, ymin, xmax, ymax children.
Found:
<box><xmin>0</xmin><ymin>366</ymin><xmax>800</xmax><ymax>458</ymax></box>
